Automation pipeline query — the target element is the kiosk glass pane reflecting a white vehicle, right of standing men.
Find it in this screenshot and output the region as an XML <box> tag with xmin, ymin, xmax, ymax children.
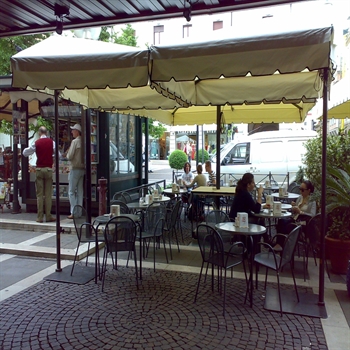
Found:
<box><xmin>109</xmin><ymin>114</ymin><xmax>135</xmax><ymax>174</ymax></box>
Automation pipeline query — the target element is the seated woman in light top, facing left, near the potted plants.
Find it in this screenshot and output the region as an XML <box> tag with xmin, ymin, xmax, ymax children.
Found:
<box><xmin>276</xmin><ymin>180</ymin><xmax>316</xmax><ymax>244</ymax></box>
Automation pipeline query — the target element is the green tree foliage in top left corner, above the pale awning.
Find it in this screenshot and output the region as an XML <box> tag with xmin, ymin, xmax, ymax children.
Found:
<box><xmin>0</xmin><ymin>33</ymin><xmax>50</xmax><ymax>75</ymax></box>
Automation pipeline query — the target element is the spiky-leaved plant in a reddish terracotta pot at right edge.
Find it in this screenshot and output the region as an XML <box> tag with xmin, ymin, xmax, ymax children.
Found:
<box><xmin>326</xmin><ymin>164</ymin><xmax>350</xmax><ymax>274</ymax></box>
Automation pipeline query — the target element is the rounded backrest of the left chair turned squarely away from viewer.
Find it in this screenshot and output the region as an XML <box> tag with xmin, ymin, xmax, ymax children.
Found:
<box><xmin>104</xmin><ymin>215</ymin><xmax>139</xmax><ymax>252</ymax></box>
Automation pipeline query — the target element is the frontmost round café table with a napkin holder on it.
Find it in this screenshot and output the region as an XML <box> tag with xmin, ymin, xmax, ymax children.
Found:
<box><xmin>215</xmin><ymin>222</ymin><xmax>266</xmax><ymax>307</ymax></box>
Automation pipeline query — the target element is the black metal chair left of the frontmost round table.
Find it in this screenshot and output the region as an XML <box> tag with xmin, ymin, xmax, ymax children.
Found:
<box><xmin>194</xmin><ymin>224</ymin><xmax>248</xmax><ymax>316</ymax></box>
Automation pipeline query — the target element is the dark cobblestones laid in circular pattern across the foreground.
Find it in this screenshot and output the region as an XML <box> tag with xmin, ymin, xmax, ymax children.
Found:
<box><xmin>0</xmin><ymin>267</ymin><xmax>327</xmax><ymax>350</ymax></box>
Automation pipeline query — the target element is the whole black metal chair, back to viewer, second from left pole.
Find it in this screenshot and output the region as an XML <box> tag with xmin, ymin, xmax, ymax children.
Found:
<box><xmin>102</xmin><ymin>215</ymin><xmax>140</xmax><ymax>291</ymax></box>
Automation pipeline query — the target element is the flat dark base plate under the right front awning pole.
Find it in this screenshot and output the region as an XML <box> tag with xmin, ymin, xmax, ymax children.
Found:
<box><xmin>264</xmin><ymin>288</ymin><xmax>328</xmax><ymax>318</ymax></box>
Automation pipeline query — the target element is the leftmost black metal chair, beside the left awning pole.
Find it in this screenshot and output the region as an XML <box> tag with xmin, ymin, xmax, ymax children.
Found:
<box><xmin>70</xmin><ymin>205</ymin><xmax>104</xmax><ymax>280</ymax></box>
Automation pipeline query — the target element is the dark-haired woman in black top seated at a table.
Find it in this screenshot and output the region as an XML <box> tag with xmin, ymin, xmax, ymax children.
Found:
<box><xmin>229</xmin><ymin>173</ymin><xmax>264</xmax><ymax>221</ymax></box>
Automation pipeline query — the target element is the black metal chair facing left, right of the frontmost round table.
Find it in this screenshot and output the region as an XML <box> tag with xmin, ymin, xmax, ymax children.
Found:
<box><xmin>254</xmin><ymin>226</ymin><xmax>301</xmax><ymax>316</ymax></box>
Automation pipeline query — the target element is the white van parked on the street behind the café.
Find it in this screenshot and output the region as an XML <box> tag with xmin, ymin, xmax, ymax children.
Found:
<box><xmin>212</xmin><ymin>130</ymin><xmax>317</xmax><ymax>184</ymax></box>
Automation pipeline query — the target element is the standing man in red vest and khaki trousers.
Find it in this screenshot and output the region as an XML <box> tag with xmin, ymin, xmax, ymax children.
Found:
<box><xmin>23</xmin><ymin>126</ymin><xmax>56</xmax><ymax>222</ymax></box>
